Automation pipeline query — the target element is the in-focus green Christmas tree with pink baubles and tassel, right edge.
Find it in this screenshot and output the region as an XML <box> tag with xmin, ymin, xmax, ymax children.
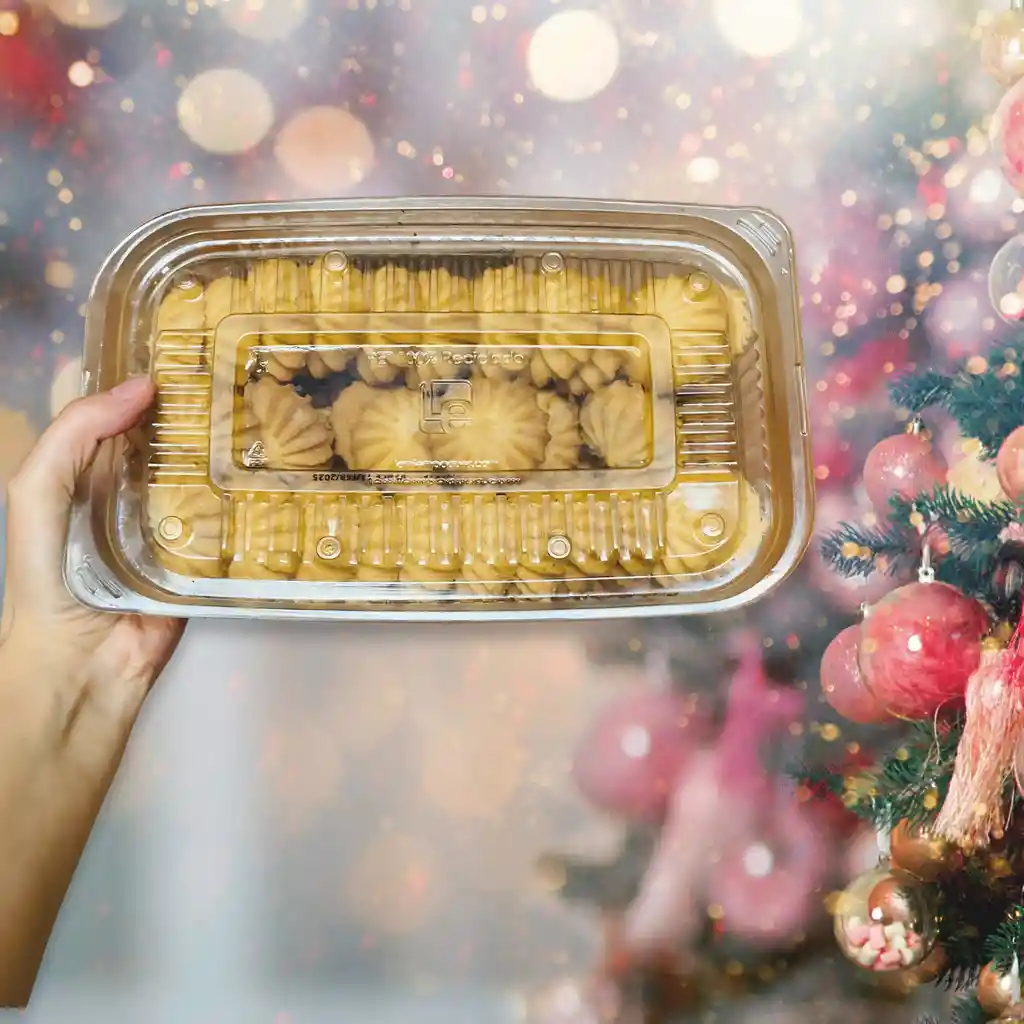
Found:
<box><xmin>817</xmin><ymin>343</ymin><xmax>1024</xmax><ymax>1024</ymax></box>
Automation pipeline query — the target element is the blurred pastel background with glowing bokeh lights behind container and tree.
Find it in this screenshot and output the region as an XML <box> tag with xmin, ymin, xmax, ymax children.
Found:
<box><xmin>0</xmin><ymin>0</ymin><xmax>1024</xmax><ymax>1024</ymax></box>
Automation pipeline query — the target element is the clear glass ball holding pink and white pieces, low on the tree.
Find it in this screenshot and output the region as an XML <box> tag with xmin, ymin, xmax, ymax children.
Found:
<box><xmin>835</xmin><ymin>867</ymin><xmax>936</xmax><ymax>973</ymax></box>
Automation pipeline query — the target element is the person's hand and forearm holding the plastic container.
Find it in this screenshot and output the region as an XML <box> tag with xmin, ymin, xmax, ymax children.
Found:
<box><xmin>0</xmin><ymin>378</ymin><xmax>184</xmax><ymax>1006</ymax></box>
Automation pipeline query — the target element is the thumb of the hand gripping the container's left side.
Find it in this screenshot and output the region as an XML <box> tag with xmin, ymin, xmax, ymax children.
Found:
<box><xmin>7</xmin><ymin>377</ymin><xmax>155</xmax><ymax>585</ymax></box>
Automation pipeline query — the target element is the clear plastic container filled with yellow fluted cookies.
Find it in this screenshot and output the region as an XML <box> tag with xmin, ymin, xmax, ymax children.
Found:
<box><xmin>67</xmin><ymin>199</ymin><xmax>813</xmax><ymax>618</ymax></box>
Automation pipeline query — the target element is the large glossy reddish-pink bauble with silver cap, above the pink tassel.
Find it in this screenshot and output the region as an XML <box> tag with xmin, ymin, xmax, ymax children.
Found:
<box><xmin>860</xmin><ymin>583</ymin><xmax>989</xmax><ymax>718</ymax></box>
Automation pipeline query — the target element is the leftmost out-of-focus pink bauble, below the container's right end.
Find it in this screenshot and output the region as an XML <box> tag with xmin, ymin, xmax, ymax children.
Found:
<box><xmin>572</xmin><ymin>690</ymin><xmax>708</xmax><ymax>821</ymax></box>
